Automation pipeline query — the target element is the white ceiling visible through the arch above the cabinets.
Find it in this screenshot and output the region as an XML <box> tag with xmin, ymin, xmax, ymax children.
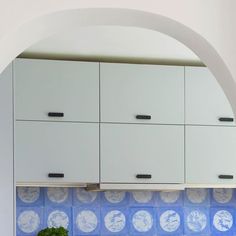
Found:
<box><xmin>20</xmin><ymin>26</ymin><xmax>202</xmax><ymax>65</ymax></box>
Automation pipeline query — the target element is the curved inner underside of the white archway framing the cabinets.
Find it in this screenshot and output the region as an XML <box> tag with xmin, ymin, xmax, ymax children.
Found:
<box><xmin>0</xmin><ymin>8</ymin><xmax>236</xmax><ymax>115</ymax></box>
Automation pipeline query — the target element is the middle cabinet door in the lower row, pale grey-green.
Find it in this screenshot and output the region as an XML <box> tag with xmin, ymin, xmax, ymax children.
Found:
<box><xmin>100</xmin><ymin>124</ymin><xmax>184</xmax><ymax>183</ymax></box>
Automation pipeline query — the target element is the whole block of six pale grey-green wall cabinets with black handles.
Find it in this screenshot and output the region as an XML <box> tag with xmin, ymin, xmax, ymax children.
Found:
<box><xmin>14</xmin><ymin>59</ymin><xmax>236</xmax><ymax>188</ymax></box>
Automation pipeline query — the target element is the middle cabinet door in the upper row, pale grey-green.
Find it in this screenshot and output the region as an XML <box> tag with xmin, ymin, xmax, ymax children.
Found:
<box><xmin>100</xmin><ymin>63</ymin><xmax>184</xmax><ymax>124</ymax></box>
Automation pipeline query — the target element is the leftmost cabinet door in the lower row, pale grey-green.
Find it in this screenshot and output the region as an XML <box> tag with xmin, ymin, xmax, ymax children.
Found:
<box><xmin>15</xmin><ymin>121</ymin><xmax>99</xmax><ymax>183</ymax></box>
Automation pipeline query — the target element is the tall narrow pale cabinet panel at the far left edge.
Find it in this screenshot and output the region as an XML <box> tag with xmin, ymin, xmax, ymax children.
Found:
<box><xmin>0</xmin><ymin>64</ymin><xmax>15</xmax><ymax>236</ymax></box>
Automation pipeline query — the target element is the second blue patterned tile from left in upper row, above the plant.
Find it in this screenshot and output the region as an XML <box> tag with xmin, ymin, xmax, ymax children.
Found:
<box><xmin>45</xmin><ymin>187</ymin><xmax>72</xmax><ymax>206</ymax></box>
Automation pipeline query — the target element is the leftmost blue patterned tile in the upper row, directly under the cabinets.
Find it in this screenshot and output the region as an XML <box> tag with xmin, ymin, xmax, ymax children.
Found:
<box><xmin>16</xmin><ymin>187</ymin><xmax>44</xmax><ymax>207</ymax></box>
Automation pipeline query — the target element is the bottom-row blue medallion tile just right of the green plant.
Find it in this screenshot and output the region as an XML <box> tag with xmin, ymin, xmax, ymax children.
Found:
<box><xmin>73</xmin><ymin>207</ymin><xmax>101</xmax><ymax>236</ymax></box>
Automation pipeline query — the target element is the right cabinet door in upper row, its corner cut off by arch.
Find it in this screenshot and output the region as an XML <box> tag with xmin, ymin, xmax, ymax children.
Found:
<box><xmin>185</xmin><ymin>67</ymin><xmax>236</xmax><ymax>126</ymax></box>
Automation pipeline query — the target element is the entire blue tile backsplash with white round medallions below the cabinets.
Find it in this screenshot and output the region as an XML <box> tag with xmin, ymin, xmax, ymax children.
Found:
<box><xmin>16</xmin><ymin>187</ymin><xmax>236</xmax><ymax>236</ymax></box>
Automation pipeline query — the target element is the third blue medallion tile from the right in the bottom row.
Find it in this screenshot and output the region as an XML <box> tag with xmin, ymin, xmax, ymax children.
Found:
<box><xmin>157</xmin><ymin>207</ymin><xmax>184</xmax><ymax>235</ymax></box>
